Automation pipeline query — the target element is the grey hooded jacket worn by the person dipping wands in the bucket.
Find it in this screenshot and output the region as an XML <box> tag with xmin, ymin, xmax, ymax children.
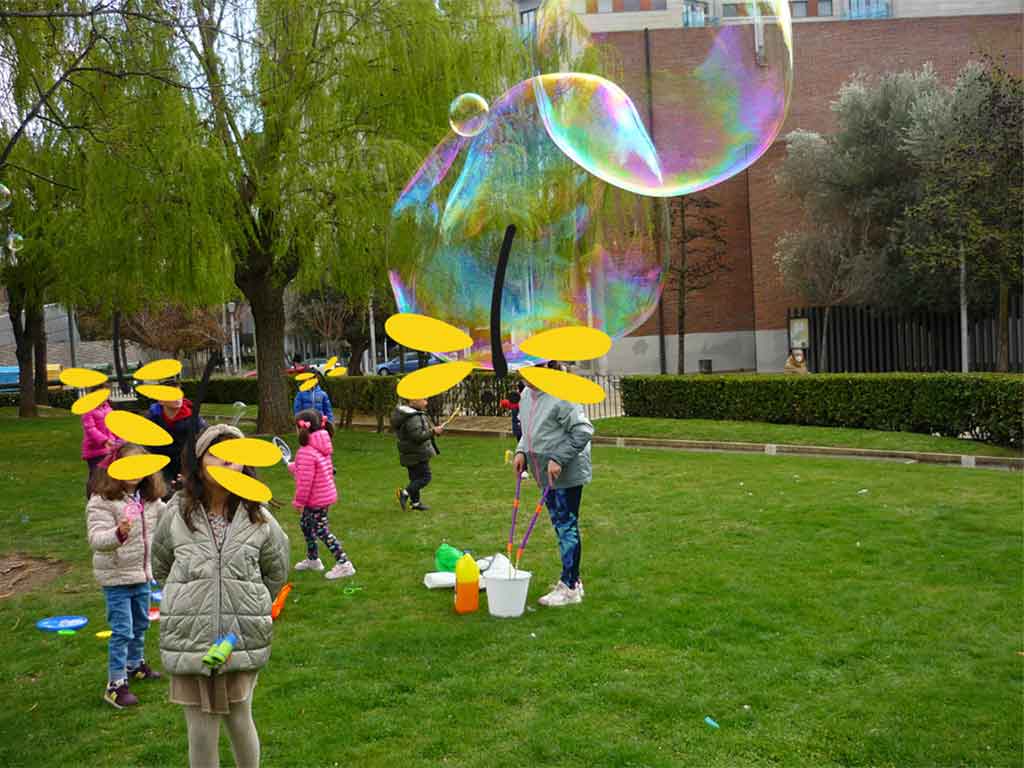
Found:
<box><xmin>516</xmin><ymin>387</ymin><xmax>594</xmax><ymax>488</ymax></box>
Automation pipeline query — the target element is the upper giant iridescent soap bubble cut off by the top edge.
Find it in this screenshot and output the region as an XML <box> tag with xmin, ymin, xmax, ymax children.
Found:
<box><xmin>534</xmin><ymin>0</ymin><xmax>793</xmax><ymax>197</ymax></box>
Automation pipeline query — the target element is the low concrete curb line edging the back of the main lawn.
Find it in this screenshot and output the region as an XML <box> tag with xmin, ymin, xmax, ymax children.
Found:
<box><xmin>339</xmin><ymin>421</ymin><xmax>1024</xmax><ymax>472</ymax></box>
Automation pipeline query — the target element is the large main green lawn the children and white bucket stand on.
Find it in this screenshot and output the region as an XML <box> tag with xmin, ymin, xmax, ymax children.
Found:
<box><xmin>0</xmin><ymin>410</ymin><xmax>1024</xmax><ymax>768</ymax></box>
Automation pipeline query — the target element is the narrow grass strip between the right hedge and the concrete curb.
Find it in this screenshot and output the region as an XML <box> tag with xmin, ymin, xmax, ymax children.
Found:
<box><xmin>594</xmin><ymin>417</ymin><xmax>1022</xmax><ymax>458</ymax></box>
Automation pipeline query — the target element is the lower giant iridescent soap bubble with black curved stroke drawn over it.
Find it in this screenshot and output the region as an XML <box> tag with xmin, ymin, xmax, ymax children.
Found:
<box><xmin>389</xmin><ymin>74</ymin><xmax>670</xmax><ymax>370</ymax></box>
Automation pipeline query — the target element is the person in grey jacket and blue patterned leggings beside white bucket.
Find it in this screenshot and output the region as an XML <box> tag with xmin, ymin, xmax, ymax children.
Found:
<box><xmin>513</xmin><ymin>366</ymin><xmax>594</xmax><ymax>607</ymax></box>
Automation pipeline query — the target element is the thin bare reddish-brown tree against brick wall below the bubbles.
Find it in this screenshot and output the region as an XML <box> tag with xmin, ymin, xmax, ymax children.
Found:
<box><xmin>670</xmin><ymin>195</ymin><xmax>730</xmax><ymax>374</ymax></box>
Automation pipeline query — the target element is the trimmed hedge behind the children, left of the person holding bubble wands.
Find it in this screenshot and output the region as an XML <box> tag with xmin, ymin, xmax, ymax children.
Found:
<box><xmin>181</xmin><ymin>374</ymin><xmax>515</xmax><ymax>429</ymax></box>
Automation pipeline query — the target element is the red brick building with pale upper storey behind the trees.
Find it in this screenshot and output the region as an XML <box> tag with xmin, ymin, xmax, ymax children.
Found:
<box><xmin>519</xmin><ymin>0</ymin><xmax>1024</xmax><ymax>373</ymax></box>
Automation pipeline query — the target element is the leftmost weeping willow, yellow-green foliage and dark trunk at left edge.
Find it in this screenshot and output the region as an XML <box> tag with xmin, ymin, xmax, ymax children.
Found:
<box><xmin>0</xmin><ymin>0</ymin><xmax>232</xmax><ymax>416</ymax></box>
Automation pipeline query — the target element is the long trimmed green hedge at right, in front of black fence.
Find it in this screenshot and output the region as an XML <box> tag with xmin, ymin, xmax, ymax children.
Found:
<box><xmin>623</xmin><ymin>374</ymin><xmax>1024</xmax><ymax>447</ymax></box>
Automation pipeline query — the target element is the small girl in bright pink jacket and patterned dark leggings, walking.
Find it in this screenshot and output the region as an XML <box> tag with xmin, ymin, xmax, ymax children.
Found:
<box><xmin>288</xmin><ymin>410</ymin><xmax>355</xmax><ymax>579</ymax></box>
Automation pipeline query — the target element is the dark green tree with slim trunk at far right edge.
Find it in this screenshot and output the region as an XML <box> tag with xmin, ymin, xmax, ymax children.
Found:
<box><xmin>905</xmin><ymin>57</ymin><xmax>1024</xmax><ymax>371</ymax></box>
